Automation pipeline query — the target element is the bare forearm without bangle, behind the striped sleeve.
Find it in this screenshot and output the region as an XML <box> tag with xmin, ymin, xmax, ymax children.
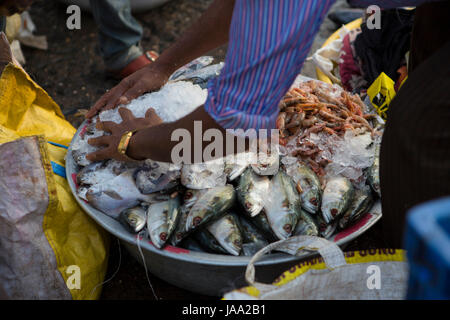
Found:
<box><xmin>156</xmin><ymin>0</ymin><xmax>235</xmax><ymax>73</ymax></box>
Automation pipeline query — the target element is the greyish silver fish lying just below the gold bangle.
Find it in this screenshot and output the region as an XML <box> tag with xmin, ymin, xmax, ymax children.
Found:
<box><xmin>134</xmin><ymin>160</ymin><xmax>181</xmax><ymax>194</ymax></box>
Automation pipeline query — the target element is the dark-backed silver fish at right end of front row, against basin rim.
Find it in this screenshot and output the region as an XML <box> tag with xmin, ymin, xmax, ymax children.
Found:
<box><xmin>339</xmin><ymin>186</ymin><xmax>374</xmax><ymax>229</ymax></box>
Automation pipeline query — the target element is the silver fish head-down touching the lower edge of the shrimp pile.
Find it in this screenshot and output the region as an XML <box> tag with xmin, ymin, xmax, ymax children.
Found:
<box><xmin>286</xmin><ymin>162</ymin><xmax>322</xmax><ymax>214</ymax></box>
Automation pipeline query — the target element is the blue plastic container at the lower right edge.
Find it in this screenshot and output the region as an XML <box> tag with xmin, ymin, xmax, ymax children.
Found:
<box><xmin>405</xmin><ymin>197</ymin><xmax>450</xmax><ymax>300</ymax></box>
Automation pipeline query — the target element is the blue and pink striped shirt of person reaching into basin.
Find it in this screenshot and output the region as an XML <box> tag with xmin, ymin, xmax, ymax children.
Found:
<box><xmin>204</xmin><ymin>0</ymin><xmax>438</xmax><ymax>130</ymax></box>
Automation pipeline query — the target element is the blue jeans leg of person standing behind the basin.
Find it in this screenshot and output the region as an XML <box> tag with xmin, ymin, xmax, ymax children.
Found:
<box><xmin>90</xmin><ymin>0</ymin><xmax>143</xmax><ymax>70</ymax></box>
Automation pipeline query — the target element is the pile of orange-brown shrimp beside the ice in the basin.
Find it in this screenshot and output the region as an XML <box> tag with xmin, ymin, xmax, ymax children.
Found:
<box><xmin>276</xmin><ymin>80</ymin><xmax>378</xmax><ymax>177</ymax></box>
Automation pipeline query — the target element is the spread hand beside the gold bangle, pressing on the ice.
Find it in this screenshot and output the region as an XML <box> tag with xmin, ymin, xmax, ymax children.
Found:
<box><xmin>86</xmin><ymin>108</ymin><xmax>162</xmax><ymax>162</ymax></box>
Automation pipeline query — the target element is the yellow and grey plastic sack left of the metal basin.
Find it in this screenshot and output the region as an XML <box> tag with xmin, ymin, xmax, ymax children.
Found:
<box><xmin>0</xmin><ymin>64</ymin><xmax>109</xmax><ymax>299</ymax></box>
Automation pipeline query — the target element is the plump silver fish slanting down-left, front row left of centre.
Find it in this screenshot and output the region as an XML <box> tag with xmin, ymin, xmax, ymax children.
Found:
<box><xmin>185</xmin><ymin>184</ymin><xmax>236</xmax><ymax>232</ymax></box>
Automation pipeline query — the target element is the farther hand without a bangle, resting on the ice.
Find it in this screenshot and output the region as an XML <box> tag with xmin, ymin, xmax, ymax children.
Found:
<box><xmin>86</xmin><ymin>62</ymin><xmax>170</xmax><ymax>118</ymax></box>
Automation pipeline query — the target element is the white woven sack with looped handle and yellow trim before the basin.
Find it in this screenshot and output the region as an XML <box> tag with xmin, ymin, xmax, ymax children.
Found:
<box><xmin>224</xmin><ymin>236</ymin><xmax>408</xmax><ymax>300</ymax></box>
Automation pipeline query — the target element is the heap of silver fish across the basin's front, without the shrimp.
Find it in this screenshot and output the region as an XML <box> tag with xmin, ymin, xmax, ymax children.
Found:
<box><xmin>77</xmin><ymin>148</ymin><xmax>378</xmax><ymax>255</ymax></box>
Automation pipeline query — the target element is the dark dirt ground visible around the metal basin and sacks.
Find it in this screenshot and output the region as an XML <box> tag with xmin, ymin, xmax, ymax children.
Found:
<box><xmin>23</xmin><ymin>0</ymin><xmax>383</xmax><ymax>300</ymax></box>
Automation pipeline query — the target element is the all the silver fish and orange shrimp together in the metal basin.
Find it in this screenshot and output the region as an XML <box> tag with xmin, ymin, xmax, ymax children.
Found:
<box><xmin>72</xmin><ymin>66</ymin><xmax>380</xmax><ymax>256</ymax></box>
